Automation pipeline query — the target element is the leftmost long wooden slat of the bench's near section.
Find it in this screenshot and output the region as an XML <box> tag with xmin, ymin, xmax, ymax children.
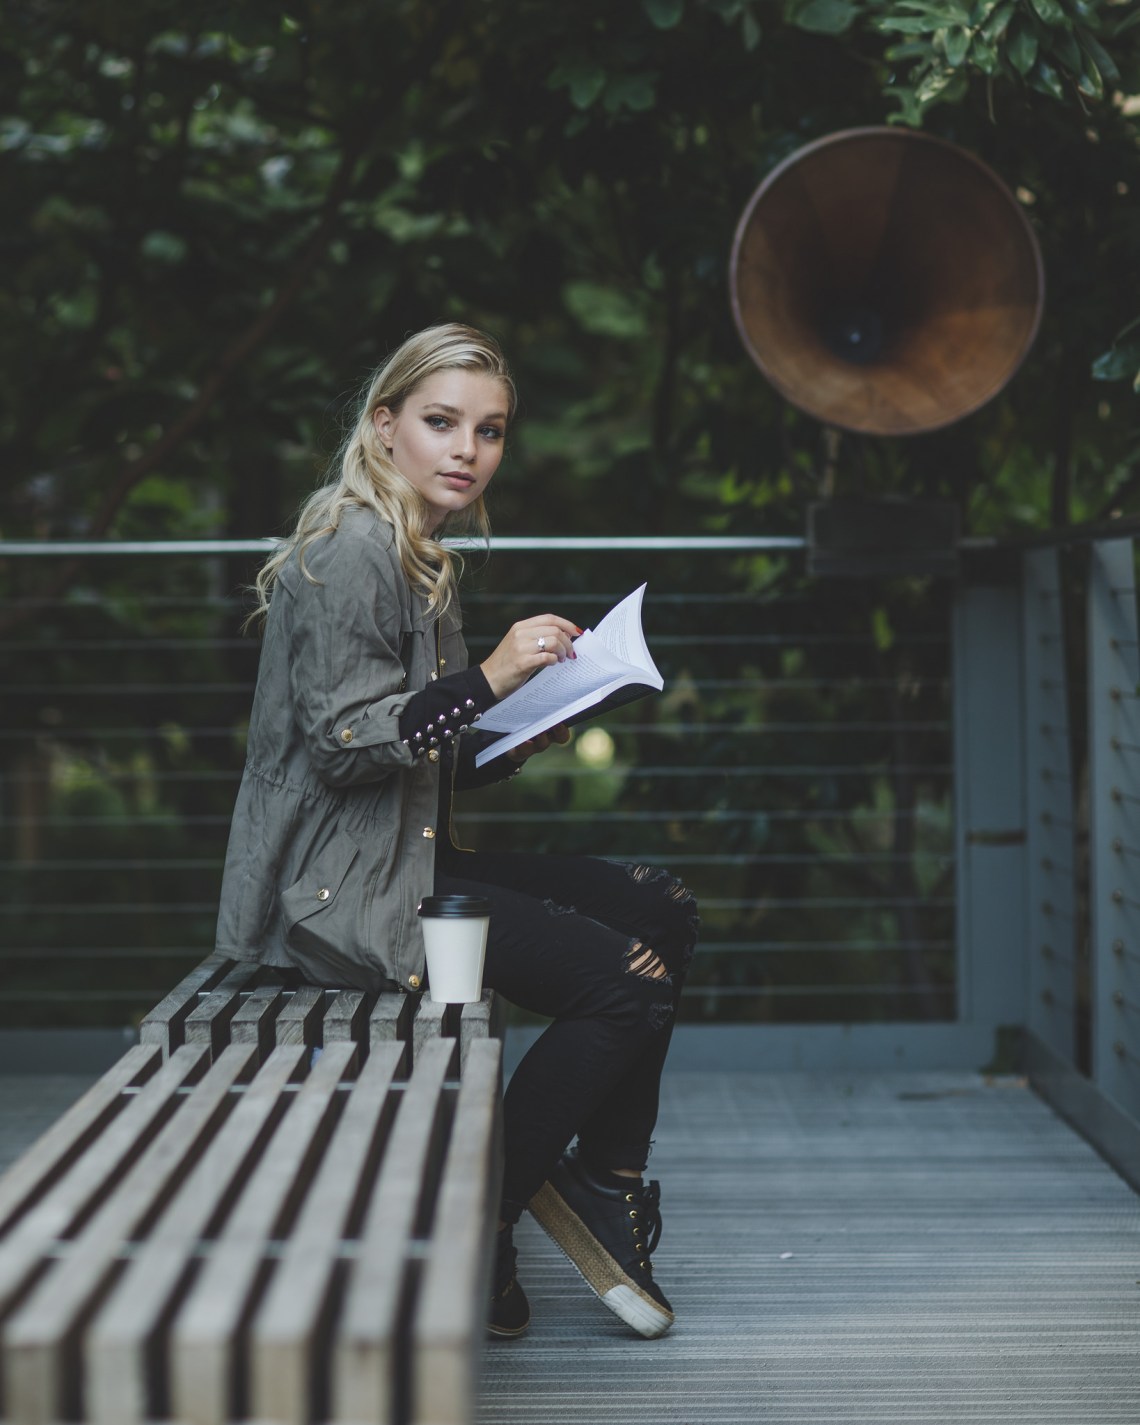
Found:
<box><xmin>0</xmin><ymin>1046</ymin><xmax>209</xmax><ymax>1317</ymax></box>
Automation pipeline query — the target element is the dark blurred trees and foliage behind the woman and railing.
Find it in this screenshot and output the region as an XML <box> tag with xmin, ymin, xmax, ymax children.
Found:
<box><xmin>0</xmin><ymin>0</ymin><xmax>1140</xmax><ymax>1022</ymax></box>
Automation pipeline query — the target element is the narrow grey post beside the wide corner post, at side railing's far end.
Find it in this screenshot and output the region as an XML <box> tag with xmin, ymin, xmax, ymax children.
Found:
<box><xmin>1022</xmin><ymin>549</ymin><xmax>1077</xmax><ymax>1063</ymax></box>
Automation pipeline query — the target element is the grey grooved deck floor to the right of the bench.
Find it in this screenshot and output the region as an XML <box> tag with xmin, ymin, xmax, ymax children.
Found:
<box><xmin>477</xmin><ymin>1073</ymin><xmax>1140</xmax><ymax>1425</ymax></box>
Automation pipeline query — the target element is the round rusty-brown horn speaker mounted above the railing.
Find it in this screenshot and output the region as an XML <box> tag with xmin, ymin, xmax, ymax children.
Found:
<box><xmin>731</xmin><ymin>128</ymin><xmax>1045</xmax><ymax>436</ymax></box>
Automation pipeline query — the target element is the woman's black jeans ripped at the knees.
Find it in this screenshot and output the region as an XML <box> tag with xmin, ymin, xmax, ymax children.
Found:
<box><xmin>436</xmin><ymin>846</ymin><xmax>698</xmax><ymax>1223</ymax></box>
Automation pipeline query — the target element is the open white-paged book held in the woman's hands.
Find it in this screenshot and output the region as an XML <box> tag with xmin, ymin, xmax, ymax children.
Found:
<box><xmin>475</xmin><ymin>584</ymin><xmax>665</xmax><ymax>767</ymax></box>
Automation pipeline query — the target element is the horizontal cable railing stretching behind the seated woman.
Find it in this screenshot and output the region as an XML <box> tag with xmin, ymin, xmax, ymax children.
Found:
<box><xmin>0</xmin><ymin>537</ymin><xmax>959</xmax><ymax>1026</ymax></box>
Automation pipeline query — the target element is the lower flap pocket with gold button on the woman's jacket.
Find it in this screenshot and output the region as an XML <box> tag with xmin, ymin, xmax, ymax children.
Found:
<box><xmin>281</xmin><ymin>832</ymin><xmax>376</xmax><ymax>989</ymax></box>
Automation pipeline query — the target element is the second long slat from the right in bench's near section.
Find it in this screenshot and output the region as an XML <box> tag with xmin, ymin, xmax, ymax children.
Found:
<box><xmin>331</xmin><ymin>1039</ymin><xmax>456</xmax><ymax>1425</ymax></box>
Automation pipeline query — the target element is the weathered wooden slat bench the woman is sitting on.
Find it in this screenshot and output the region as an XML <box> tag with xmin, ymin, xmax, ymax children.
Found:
<box><xmin>0</xmin><ymin>959</ymin><xmax>502</xmax><ymax>1425</ymax></box>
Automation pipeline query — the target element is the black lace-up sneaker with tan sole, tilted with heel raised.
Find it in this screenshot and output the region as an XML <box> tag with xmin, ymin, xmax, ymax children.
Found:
<box><xmin>530</xmin><ymin>1149</ymin><xmax>673</xmax><ymax>1338</ymax></box>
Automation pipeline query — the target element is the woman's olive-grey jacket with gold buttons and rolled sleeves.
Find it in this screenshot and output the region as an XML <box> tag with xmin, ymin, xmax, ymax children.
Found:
<box><xmin>217</xmin><ymin>509</ymin><xmax>467</xmax><ymax>989</ymax></box>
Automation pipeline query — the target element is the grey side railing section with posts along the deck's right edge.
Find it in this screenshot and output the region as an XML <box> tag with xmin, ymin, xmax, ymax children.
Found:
<box><xmin>1022</xmin><ymin>529</ymin><xmax>1140</xmax><ymax>1157</ymax></box>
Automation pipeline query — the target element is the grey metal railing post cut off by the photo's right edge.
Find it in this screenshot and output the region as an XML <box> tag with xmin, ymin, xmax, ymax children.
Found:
<box><xmin>1089</xmin><ymin>539</ymin><xmax>1140</xmax><ymax>1117</ymax></box>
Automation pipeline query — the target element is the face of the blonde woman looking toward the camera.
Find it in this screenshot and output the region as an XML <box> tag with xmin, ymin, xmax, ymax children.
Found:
<box><xmin>372</xmin><ymin>369</ymin><xmax>509</xmax><ymax>534</ymax></box>
